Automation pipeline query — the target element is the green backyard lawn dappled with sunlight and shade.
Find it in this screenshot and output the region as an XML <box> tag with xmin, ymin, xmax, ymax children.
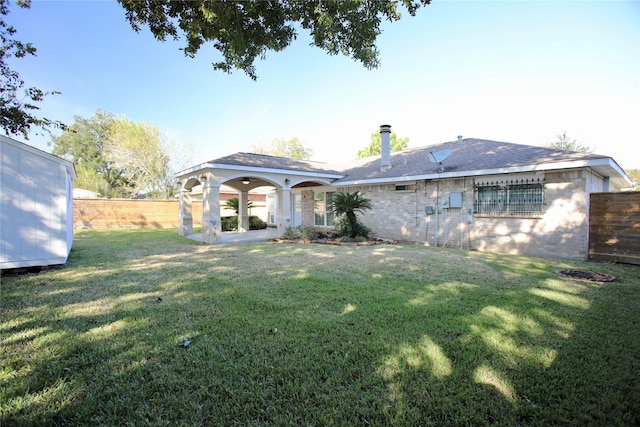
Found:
<box><xmin>0</xmin><ymin>230</ymin><xmax>640</xmax><ymax>426</ymax></box>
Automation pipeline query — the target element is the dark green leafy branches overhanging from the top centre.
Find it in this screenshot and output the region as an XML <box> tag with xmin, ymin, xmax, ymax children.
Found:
<box><xmin>118</xmin><ymin>0</ymin><xmax>430</xmax><ymax>80</ymax></box>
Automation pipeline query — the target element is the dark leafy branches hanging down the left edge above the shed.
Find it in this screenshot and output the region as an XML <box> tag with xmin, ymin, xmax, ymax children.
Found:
<box><xmin>0</xmin><ymin>0</ymin><xmax>65</xmax><ymax>139</ymax></box>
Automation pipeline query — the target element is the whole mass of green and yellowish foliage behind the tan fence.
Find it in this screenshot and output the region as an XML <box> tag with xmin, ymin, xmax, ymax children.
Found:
<box><xmin>51</xmin><ymin>111</ymin><xmax>180</xmax><ymax>199</ymax></box>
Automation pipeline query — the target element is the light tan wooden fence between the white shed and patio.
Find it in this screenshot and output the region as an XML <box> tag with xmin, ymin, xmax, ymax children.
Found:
<box><xmin>73</xmin><ymin>199</ymin><xmax>202</xmax><ymax>229</ymax></box>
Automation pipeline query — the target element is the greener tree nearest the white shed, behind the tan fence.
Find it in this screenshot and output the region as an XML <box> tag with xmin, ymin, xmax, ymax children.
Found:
<box><xmin>49</xmin><ymin>110</ymin><xmax>132</xmax><ymax>197</ymax></box>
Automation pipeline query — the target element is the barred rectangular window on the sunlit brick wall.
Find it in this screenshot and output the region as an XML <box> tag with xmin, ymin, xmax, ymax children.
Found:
<box><xmin>473</xmin><ymin>179</ymin><xmax>544</xmax><ymax>215</ymax></box>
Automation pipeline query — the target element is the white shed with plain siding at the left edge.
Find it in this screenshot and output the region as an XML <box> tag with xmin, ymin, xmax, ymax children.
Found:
<box><xmin>0</xmin><ymin>135</ymin><xmax>77</xmax><ymax>269</ymax></box>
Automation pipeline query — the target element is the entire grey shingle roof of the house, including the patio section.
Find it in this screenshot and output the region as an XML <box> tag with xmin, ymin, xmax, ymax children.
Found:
<box><xmin>198</xmin><ymin>138</ymin><xmax>627</xmax><ymax>187</ymax></box>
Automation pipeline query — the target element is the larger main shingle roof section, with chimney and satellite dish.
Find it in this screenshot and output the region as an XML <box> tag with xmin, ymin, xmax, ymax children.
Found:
<box><xmin>336</xmin><ymin>138</ymin><xmax>608</xmax><ymax>184</ymax></box>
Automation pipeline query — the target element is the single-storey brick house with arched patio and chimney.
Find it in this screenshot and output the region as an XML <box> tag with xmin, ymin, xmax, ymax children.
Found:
<box><xmin>177</xmin><ymin>125</ymin><xmax>632</xmax><ymax>260</ymax></box>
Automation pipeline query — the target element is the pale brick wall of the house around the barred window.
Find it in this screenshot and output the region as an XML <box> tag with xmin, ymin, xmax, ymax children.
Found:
<box><xmin>303</xmin><ymin>169</ymin><xmax>604</xmax><ymax>260</ymax></box>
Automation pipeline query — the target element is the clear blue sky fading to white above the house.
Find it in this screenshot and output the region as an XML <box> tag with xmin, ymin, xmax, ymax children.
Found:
<box><xmin>7</xmin><ymin>0</ymin><xmax>640</xmax><ymax>168</ymax></box>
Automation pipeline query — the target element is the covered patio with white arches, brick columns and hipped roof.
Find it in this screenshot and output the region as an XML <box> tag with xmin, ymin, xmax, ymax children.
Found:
<box><xmin>176</xmin><ymin>153</ymin><xmax>343</xmax><ymax>244</ymax></box>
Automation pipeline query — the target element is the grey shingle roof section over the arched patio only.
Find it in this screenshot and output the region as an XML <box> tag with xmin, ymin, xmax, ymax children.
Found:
<box><xmin>208</xmin><ymin>153</ymin><xmax>344</xmax><ymax>175</ymax></box>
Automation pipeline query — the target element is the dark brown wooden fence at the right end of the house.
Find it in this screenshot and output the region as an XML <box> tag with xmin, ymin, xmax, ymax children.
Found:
<box><xmin>589</xmin><ymin>191</ymin><xmax>640</xmax><ymax>265</ymax></box>
